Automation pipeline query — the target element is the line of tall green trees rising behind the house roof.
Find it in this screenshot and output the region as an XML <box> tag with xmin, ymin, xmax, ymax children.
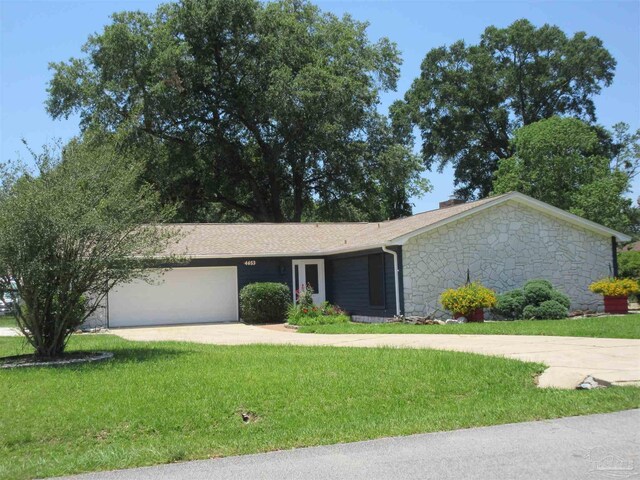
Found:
<box><xmin>47</xmin><ymin>0</ymin><xmax>639</xmax><ymax>231</ymax></box>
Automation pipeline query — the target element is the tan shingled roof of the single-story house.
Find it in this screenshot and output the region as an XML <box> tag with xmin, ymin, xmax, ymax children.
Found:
<box><xmin>162</xmin><ymin>192</ymin><xmax>625</xmax><ymax>258</ymax></box>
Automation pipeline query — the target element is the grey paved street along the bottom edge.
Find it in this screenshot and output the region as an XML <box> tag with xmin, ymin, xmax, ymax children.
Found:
<box><xmin>51</xmin><ymin>410</ymin><xmax>640</xmax><ymax>480</ymax></box>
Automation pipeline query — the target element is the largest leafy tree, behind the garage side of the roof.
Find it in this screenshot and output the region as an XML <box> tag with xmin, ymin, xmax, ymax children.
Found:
<box><xmin>47</xmin><ymin>0</ymin><xmax>424</xmax><ymax>222</ymax></box>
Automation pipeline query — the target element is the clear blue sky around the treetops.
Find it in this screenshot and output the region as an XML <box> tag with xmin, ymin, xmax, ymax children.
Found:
<box><xmin>0</xmin><ymin>0</ymin><xmax>640</xmax><ymax>211</ymax></box>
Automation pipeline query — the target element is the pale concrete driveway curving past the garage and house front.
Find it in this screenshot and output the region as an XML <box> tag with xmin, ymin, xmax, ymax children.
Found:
<box><xmin>112</xmin><ymin>323</ymin><xmax>640</xmax><ymax>388</ymax></box>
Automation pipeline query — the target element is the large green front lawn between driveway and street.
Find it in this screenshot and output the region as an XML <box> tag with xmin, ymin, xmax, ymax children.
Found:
<box><xmin>0</xmin><ymin>335</ymin><xmax>640</xmax><ymax>480</ymax></box>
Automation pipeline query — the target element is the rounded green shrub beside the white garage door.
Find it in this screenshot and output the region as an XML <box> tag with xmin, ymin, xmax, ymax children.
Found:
<box><xmin>240</xmin><ymin>282</ymin><xmax>291</xmax><ymax>323</ymax></box>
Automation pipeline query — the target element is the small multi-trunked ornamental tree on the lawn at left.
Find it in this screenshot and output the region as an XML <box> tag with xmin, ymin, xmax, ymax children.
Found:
<box><xmin>0</xmin><ymin>140</ymin><xmax>176</xmax><ymax>358</ymax></box>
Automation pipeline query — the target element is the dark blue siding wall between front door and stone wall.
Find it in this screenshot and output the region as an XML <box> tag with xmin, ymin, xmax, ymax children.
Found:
<box><xmin>325</xmin><ymin>249</ymin><xmax>402</xmax><ymax>317</ymax></box>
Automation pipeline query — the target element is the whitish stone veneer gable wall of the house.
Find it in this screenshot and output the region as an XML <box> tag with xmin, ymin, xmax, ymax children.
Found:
<box><xmin>402</xmin><ymin>202</ymin><xmax>612</xmax><ymax>317</ymax></box>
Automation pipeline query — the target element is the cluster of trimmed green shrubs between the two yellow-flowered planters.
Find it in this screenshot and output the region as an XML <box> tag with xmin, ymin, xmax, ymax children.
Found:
<box><xmin>491</xmin><ymin>280</ymin><xmax>571</xmax><ymax>320</ymax></box>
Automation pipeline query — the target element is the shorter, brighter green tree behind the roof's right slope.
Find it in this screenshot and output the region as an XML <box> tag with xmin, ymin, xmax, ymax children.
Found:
<box><xmin>493</xmin><ymin>117</ymin><xmax>633</xmax><ymax>231</ymax></box>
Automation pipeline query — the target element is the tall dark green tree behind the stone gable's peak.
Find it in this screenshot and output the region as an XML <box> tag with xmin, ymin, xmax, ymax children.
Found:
<box><xmin>392</xmin><ymin>20</ymin><xmax>616</xmax><ymax>199</ymax></box>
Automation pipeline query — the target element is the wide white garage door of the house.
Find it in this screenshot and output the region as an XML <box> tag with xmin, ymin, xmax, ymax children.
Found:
<box><xmin>109</xmin><ymin>267</ymin><xmax>238</xmax><ymax>327</ymax></box>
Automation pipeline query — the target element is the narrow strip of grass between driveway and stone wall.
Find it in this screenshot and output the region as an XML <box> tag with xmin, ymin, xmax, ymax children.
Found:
<box><xmin>298</xmin><ymin>315</ymin><xmax>640</xmax><ymax>338</ymax></box>
